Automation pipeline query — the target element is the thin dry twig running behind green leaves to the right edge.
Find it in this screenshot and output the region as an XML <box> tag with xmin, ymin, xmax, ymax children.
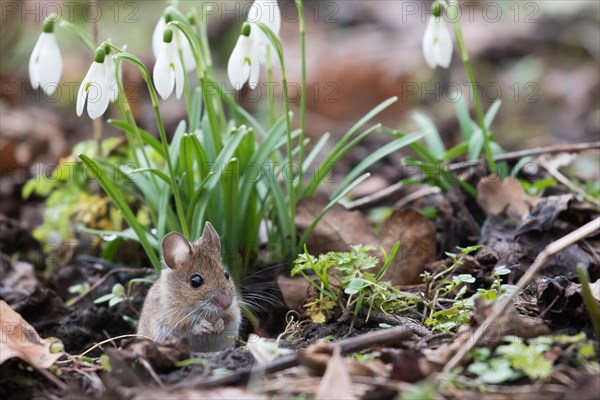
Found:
<box><xmin>346</xmin><ymin>142</ymin><xmax>600</xmax><ymax>210</ymax></box>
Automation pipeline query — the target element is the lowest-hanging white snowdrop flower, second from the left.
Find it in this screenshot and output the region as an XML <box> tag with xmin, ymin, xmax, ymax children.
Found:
<box><xmin>77</xmin><ymin>47</ymin><xmax>111</xmax><ymax>119</ymax></box>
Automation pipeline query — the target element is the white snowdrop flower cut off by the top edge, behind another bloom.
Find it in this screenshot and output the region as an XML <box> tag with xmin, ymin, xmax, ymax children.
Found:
<box><xmin>248</xmin><ymin>0</ymin><xmax>281</xmax><ymax>64</ymax></box>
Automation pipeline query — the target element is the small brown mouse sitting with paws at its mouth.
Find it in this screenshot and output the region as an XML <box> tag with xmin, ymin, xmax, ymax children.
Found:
<box><xmin>137</xmin><ymin>222</ymin><xmax>241</xmax><ymax>352</ymax></box>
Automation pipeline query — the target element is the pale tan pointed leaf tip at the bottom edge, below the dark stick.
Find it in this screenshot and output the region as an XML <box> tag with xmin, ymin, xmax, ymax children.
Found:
<box><xmin>315</xmin><ymin>346</ymin><xmax>356</xmax><ymax>400</ymax></box>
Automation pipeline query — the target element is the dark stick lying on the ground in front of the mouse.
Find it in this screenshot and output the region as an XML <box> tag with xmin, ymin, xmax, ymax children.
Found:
<box><xmin>180</xmin><ymin>326</ymin><xmax>413</xmax><ymax>388</ymax></box>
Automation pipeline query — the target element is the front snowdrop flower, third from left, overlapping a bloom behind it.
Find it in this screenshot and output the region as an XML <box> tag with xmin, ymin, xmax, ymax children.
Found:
<box><xmin>153</xmin><ymin>29</ymin><xmax>185</xmax><ymax>100</ymax></box>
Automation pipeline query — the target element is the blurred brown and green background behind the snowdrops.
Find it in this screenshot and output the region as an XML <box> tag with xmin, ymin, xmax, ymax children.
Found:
<box><xmin>0</xmin><ymin>0</ymin><xmax>600</xmax><ymax>225</ymax></box>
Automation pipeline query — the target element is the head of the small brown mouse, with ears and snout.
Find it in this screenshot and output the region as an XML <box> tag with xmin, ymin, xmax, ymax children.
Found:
<box><xmin>162</xmin><ymin>222</ymin><xmax>235</xmax><ymax>314</ymax></box>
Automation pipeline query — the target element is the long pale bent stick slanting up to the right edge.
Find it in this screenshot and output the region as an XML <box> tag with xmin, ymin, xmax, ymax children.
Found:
<box><xmin>443</xmin><ymin>218</ymin><xmax>600</xmax><ymax>373</ymax></box>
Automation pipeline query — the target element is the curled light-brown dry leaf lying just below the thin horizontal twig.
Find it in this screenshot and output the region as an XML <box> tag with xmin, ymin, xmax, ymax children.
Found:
<box><xmin>477</xmin><ymin>176</ymin><xmax>536</xmax><ymax>218</ymax></box>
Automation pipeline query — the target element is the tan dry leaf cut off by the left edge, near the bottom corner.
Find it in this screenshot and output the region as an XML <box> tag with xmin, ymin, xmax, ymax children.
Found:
<box><xmin>0</xmin><ymin>300</ymin><xmax>62</xmax><ymax>368</ymax></box>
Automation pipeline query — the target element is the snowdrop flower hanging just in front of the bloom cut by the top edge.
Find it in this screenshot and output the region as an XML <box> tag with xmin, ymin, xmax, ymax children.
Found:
<box><xmin>227</xmin><ymin>22</ymin><xmax>260</xmax><ymax>90</ymax></box>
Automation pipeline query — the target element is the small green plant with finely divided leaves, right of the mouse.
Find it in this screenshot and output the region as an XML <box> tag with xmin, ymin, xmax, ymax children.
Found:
<box><xmin>292</xmin><ymin>242</ymin><xmax>418</xmax><ymax>323</ymax></box>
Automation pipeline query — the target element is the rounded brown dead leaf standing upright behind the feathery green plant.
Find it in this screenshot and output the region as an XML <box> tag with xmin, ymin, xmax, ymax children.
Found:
<box><xmin>381</xmin><ymin>208</ymin><xmax>436</xmax><ymax>285</ymax></box>
